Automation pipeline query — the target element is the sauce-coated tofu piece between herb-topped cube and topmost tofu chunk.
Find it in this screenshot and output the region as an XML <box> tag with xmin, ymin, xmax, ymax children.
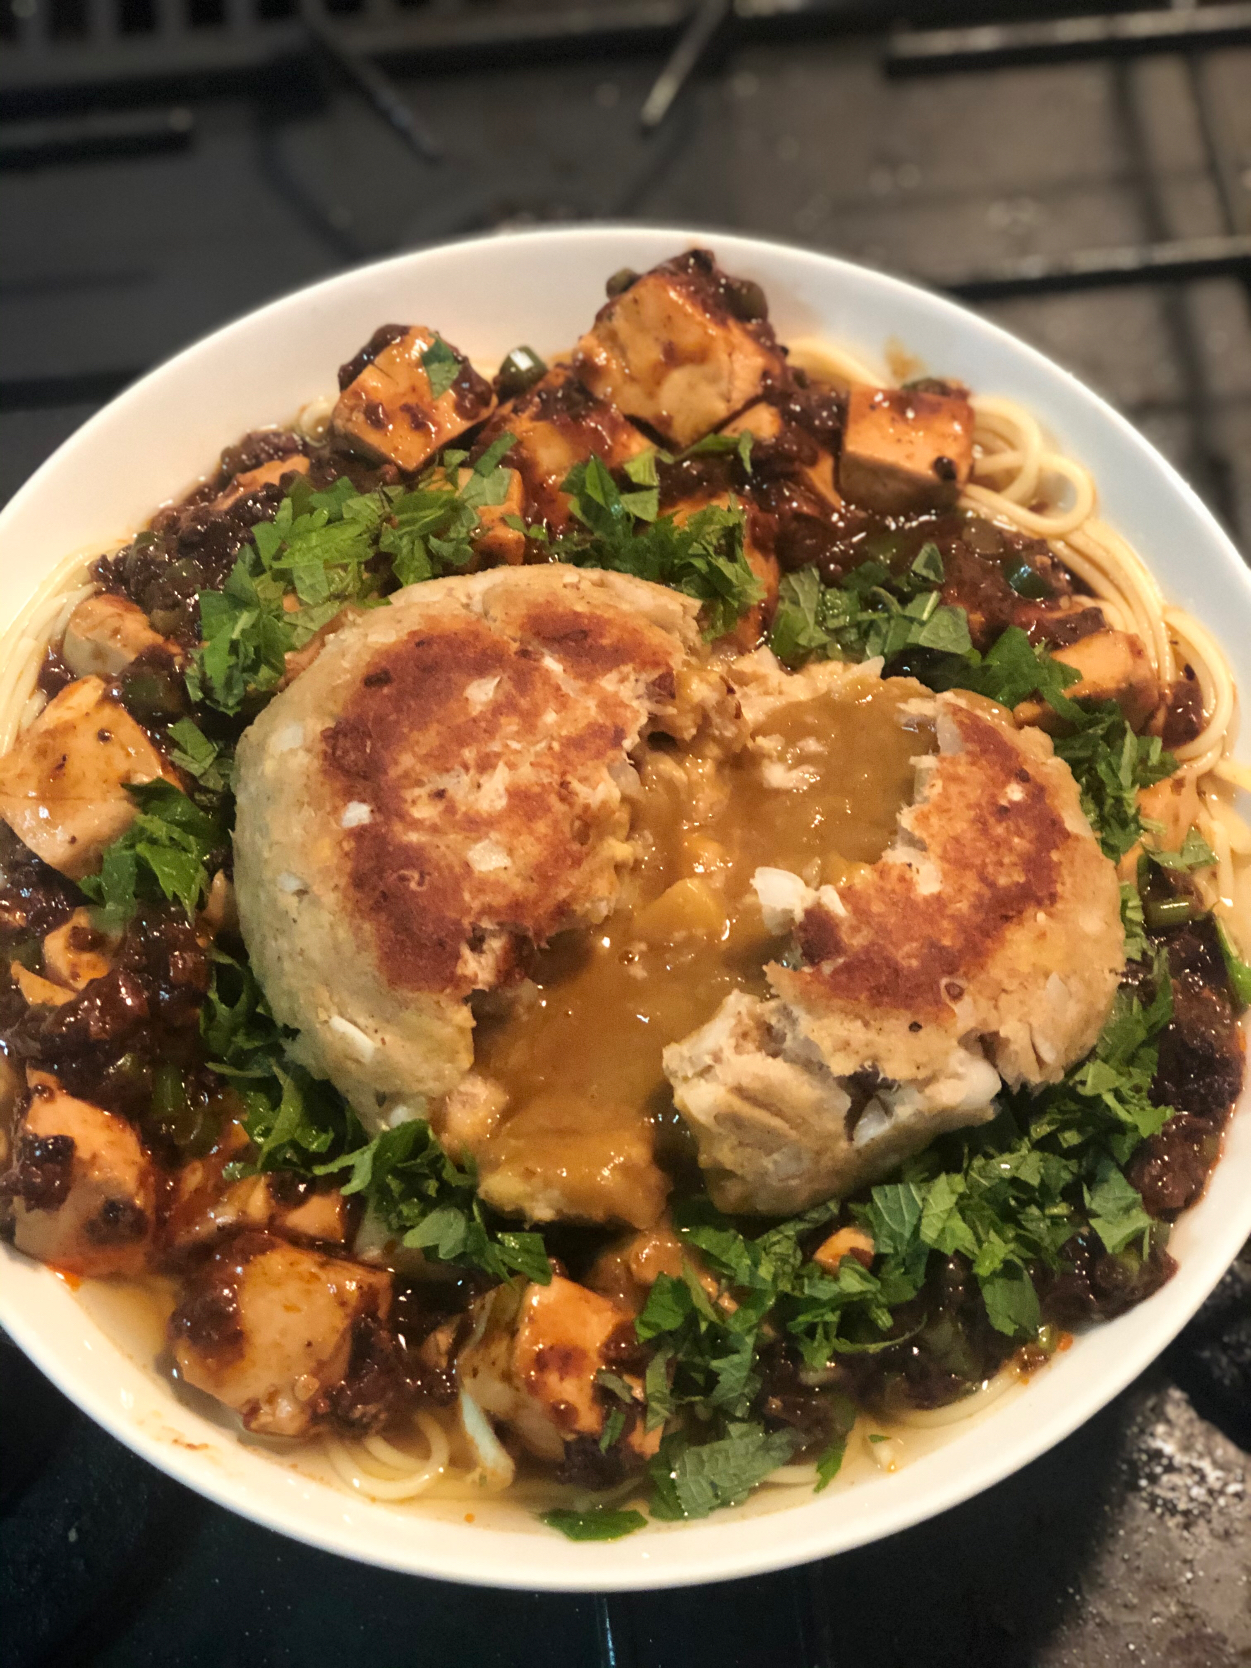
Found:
<box><xmin>474</xmin><ymin>365</ymin><xmax>649</xmax><ymax>537</ymax></box>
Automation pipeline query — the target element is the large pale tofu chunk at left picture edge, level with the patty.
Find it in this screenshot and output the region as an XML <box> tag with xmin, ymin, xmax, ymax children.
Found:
<box><xmin>0</xmin><ymin>677</ymin><xmax>174</xmax><ymax>881</ymax></box>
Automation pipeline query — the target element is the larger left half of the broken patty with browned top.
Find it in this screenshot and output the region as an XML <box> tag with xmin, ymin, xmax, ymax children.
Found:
<box><xmin>235</xmin><ymin>565</ymin><xmax>701</xmax><ymax>1123</ymax></box>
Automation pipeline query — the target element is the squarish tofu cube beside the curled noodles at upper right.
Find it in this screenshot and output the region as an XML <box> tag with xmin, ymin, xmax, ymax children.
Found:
<box><xmin>839</xmin><ymin>387</ymin><xmax>972</xmax><ymax>515</ymax></box>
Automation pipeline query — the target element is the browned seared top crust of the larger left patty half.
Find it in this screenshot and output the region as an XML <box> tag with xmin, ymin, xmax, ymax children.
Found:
<box><xmin>322</xmin><ymin>600</ymin><xmax>690</xmax><ymax>996</ymax></box>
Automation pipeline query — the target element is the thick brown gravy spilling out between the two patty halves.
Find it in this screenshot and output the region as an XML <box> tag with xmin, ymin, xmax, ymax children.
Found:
<box><xmin>475</xmin><ymin>679</ymin><xmax>934</xmax><ymax>1200</ymax></box>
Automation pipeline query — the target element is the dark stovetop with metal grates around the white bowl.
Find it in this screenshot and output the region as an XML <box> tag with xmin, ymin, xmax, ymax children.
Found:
<box><xmin>0</xmin><ymin>0</ymin><xmax>1251</xmax><ymax>1668</ymax></box>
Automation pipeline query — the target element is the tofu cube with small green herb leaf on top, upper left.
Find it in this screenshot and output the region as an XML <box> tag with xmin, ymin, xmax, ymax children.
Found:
<box><xmin>330</xmin><ymin>324</ymin><xmax>495</xmax><ymax>472</ymax></box>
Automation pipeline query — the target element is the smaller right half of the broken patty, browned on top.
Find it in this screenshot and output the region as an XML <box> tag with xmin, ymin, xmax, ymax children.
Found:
<box><xmin>664</xmin><ymin>680</ymin><xmax>1124</xmax><ymax>1214</ymax></box>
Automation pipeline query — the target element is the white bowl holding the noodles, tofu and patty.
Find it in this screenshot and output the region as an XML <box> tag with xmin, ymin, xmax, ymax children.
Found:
<box><xmin>0</xmin><ymin>227</ymin><xmax>1251</xmax><ymax>1590</ymax></box>
